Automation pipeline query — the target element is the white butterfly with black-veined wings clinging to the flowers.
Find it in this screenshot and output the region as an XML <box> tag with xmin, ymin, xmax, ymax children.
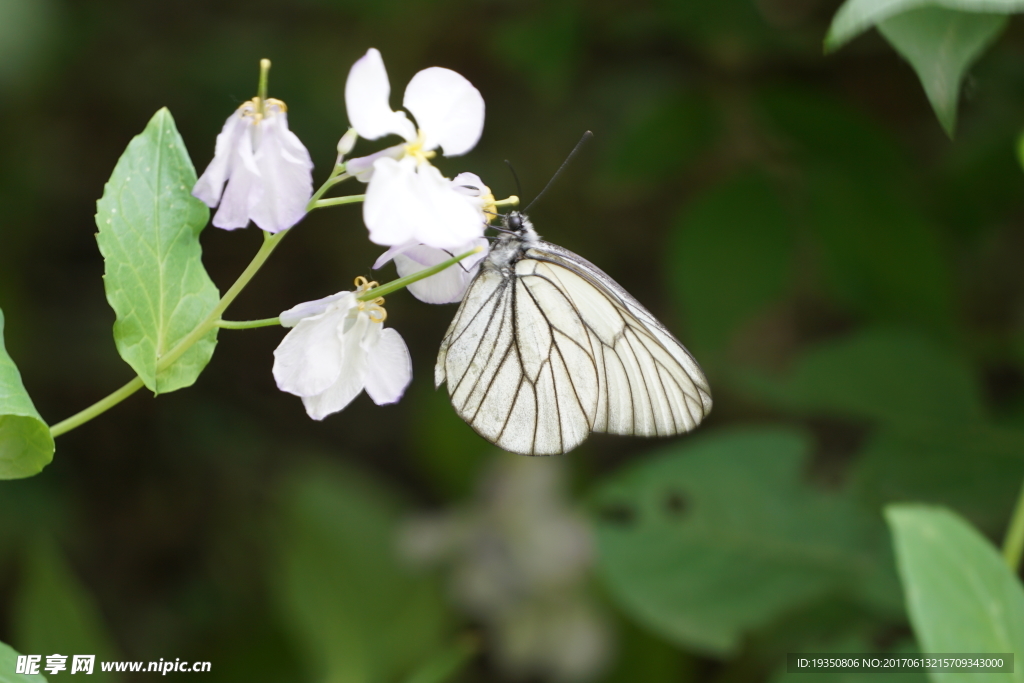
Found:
<box><xmin>434</xmin><ymin>211</ymin><xmax>712</xmax><ymax>456</ymax></box>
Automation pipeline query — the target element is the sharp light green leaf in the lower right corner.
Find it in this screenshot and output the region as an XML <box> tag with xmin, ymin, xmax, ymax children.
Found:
<box><xmin>886</xmin><ymin>505</ymin><xmax>1024</xmax><ymax>682</ymax></box>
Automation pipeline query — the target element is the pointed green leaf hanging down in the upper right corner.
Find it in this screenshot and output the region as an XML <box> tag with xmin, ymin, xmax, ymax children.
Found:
<box><xmin>879</xmin><ymin>7</ymin><xmax>1008</xmax><ymax>137</ymax></box>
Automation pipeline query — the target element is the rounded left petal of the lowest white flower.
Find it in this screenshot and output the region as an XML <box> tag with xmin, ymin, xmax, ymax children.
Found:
<box><xmin>273</xmin><ymin>309</ymin><xmax>346</xmax><ymax>397</ymax></box>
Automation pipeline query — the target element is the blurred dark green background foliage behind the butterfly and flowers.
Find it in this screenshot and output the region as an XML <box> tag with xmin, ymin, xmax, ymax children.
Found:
<box><xmin>0</xmin><ymin>0</ymin><xmax>1024</xmax><ymax>683</ymax></box>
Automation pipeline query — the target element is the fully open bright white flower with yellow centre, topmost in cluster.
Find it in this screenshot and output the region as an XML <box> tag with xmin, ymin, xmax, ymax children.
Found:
<box><xmin>345</xmin><ymin>48</ymin><xmax>486</xmax><ymax>249</ymax></box>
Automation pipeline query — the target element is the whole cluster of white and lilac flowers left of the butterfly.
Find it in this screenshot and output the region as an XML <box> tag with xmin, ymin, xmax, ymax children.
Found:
<box><xmin>193</xmin><ymin>49</ymin><xmax>496</xmax><ymax>420</ymax></box>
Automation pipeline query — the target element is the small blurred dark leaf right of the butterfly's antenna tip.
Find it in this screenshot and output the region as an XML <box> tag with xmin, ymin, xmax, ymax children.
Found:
<box><xmin>604</xmin><ymin>91</ymin><xmax>720</xmax><ymax>189</ymax></box>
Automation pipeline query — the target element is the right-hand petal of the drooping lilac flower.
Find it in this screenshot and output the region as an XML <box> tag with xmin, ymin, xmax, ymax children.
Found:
<box><xmin>250</xmin><ymin>111</ymin><xmax>313</xmax><ymax>232</ymax></box>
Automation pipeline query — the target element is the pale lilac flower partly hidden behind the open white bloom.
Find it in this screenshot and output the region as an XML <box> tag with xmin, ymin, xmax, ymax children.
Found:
<box><xmin>374</xmin><ymin>173</ymin><xmax>495</xmax><ymax>303</ymax></box>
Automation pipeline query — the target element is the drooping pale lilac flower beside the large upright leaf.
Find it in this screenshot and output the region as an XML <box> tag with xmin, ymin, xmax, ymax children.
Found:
<box><xmin>193</xmin><ymin>97</ymin><xmax>313</xmax><ymax>232</ymax></box>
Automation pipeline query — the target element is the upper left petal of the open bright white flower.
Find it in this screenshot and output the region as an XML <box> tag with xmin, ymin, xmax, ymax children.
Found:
<box><xmin>345</xmin><ymin>47</ymin><xmax>416</xmax><ymax>141</ymax></box>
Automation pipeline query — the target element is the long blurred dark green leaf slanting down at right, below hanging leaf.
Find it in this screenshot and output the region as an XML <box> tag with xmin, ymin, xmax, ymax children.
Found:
<box><xmin>761</xmin><ymin>89</ymin><xmax>954</xmax><ymax>335</ymax></box>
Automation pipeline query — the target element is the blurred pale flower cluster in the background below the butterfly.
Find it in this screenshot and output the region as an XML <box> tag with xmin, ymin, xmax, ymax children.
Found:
<box><xmin>398</xmin><ymin>454</ymin><xmax>613</xmax><ymax>682</ymax></box>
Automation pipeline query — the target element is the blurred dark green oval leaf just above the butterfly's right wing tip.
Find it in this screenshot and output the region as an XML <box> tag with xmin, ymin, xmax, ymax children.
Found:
<box><xmin>667</xmin><ymin>173</ymin><xmax>794</xmax><ymax>355</ymax></box>
